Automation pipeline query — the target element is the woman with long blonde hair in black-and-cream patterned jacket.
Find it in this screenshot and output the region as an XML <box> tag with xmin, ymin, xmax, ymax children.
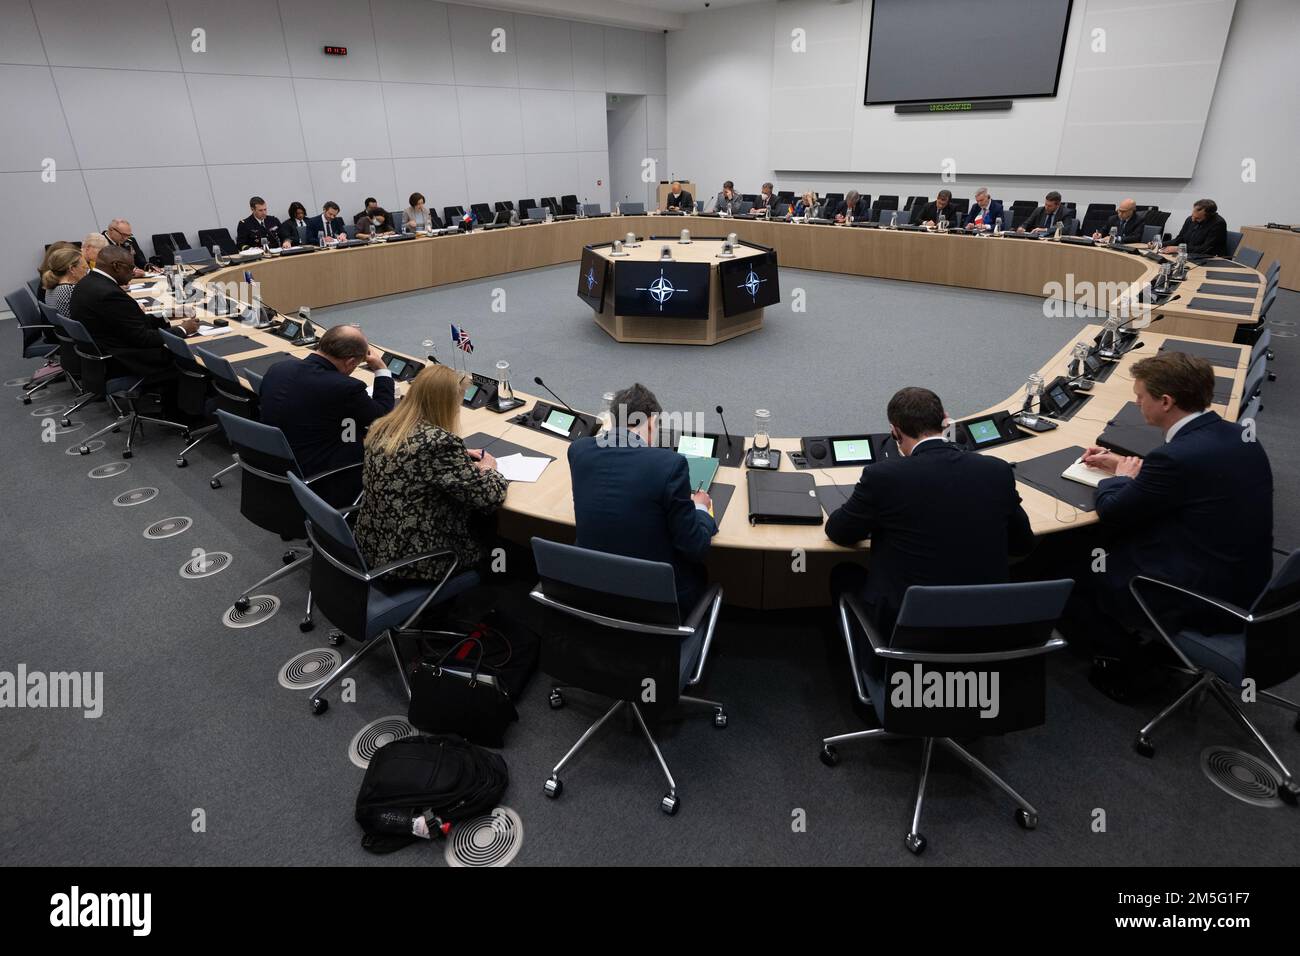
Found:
<box><xmin>356</xmin><ymin>364</ymin><xmax>506</xmax><ymax>581</ymax></box>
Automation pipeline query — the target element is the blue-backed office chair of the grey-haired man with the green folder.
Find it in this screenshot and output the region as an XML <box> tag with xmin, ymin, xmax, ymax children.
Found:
<box><xmin>530</xmin><ymin>537</ymin><xmax>727</xmax><ymax>816</ymax></box>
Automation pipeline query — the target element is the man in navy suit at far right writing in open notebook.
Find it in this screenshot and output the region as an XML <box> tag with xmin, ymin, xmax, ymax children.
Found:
<box><xmin>1076</xmin><ymin>352</ymin><xmax>1273</xmax><ymax>691</ymax></box>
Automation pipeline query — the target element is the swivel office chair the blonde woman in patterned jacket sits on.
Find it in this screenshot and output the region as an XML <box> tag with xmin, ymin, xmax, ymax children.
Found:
<box><xmin>287</xmin><ymin>472</ymin><xmax>478</xmax><ymax>714</ymax></box>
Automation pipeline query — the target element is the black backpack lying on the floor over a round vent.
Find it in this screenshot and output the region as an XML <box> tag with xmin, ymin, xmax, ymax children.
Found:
<box><xmin>356</xmin><ymin>734</ymin><xmax>510</xmax><ymax>853</ymax></box>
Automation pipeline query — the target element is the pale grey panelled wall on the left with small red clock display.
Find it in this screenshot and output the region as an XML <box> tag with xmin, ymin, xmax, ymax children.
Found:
<box><xmin>0</xmin><ymin>0</ymin><xmax>667</xmax><ymax>291</ymax></box>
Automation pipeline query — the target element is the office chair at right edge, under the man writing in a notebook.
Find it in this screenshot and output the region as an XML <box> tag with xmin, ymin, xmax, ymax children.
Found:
<box><xmin>1128</xmin><ymin>550</ymin><xmax>1300</xmax><ymax>806</ymax></box>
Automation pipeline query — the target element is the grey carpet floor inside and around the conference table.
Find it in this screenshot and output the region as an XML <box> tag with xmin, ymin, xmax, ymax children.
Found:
<box><xmin>0</xmin><ymin>267</ymin><xmax>1300</xmax><ymax>866</ymax></box>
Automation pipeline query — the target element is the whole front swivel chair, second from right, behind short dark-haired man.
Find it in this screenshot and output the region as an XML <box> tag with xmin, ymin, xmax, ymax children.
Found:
<box><xmin>820</xmin><ymin>580</ymin><xmax>1074</xmax><ymax>853</ymax></box>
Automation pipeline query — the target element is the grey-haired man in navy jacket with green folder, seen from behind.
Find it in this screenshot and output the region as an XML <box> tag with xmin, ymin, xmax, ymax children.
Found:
<box><xmin>568</xmin><ymin>384</ymin><xmax>718</xmax><ymax>614</ymax></box>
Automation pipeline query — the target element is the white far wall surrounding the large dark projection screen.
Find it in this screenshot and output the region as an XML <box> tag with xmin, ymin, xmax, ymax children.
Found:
<box><xmin>668</xmin><ymin>0</ymin><xmax>1300</xmax><ymax>226</ymax></box>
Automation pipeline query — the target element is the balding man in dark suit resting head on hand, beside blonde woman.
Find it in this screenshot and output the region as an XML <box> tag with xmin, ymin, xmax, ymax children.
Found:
<box><xmin>260</xmin><ymin>325</ymin><xmax>397</xmax><ymax>505</ymax></box>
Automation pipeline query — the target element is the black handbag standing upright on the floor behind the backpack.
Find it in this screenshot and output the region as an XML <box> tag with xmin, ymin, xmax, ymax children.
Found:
<box><xmin>407</xmin><ymin>637</ymin><xmax>519</xmax><ymax>747</ymax></box>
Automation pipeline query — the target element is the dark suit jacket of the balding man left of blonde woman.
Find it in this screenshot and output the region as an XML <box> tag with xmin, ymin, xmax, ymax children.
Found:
<box><xmin>260</xmin><ymin>355</ymin><xmax>395</xmax><ymax>477</ymax></box>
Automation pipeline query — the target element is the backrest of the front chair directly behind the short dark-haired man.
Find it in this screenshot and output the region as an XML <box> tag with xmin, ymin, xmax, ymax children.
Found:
<box><xmin>883</xmin><ymin>580</ymin><xmax>1074</xmax><ymax>736</ymax></box>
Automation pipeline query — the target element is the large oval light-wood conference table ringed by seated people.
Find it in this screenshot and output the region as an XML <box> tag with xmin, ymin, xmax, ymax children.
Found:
<box><xmin>138</xmin><ymin>216</ymin><xmax>1262</xmax><ymax>609</ymax></box>
